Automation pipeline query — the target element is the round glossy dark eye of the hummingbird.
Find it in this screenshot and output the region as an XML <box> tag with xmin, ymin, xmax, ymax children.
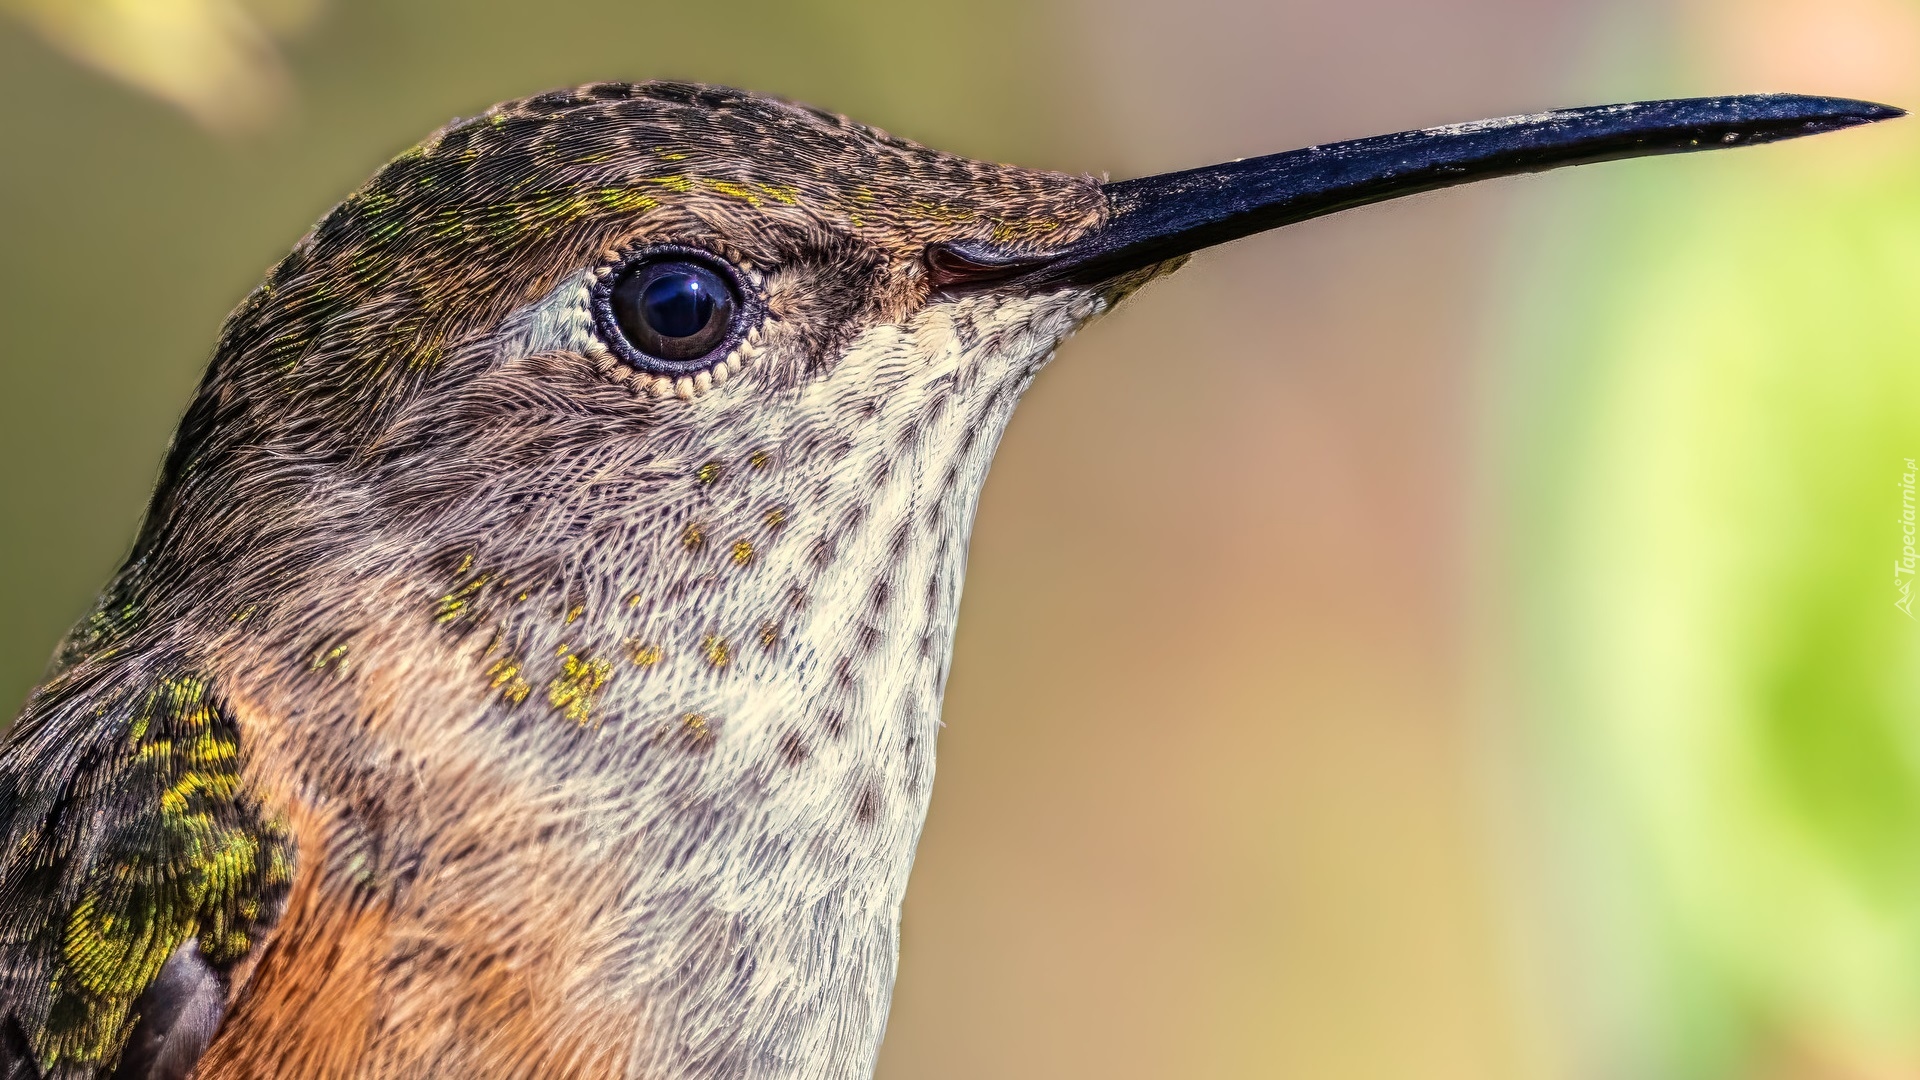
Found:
<box><xmin>595</xmin><ymin>252</ymin><xmax>743</xmax><ymax>375</ymax></box>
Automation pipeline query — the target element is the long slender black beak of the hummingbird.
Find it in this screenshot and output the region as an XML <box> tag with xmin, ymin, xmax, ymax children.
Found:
<box><xmin>927</xmin><ymin>94</ymin><xmax>1907</xmax><ymax>288</ymax></box>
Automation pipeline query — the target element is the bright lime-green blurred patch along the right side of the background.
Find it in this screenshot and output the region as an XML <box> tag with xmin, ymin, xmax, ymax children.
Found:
<box><xmin>1511</xmin><ymin>71</ymin><xmax>1920</xmax><ymax>1076</ymax></box>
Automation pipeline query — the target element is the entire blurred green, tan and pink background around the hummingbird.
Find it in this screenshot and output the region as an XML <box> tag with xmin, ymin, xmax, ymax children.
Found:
<box><xmin>0</xmin><ymin>0</ymin><xmax>1920</xmax><ymax>1080</ymax></box>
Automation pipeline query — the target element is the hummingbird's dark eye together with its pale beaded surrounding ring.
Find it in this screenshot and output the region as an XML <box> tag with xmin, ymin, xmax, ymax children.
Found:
<box><xmin>589</xmin><ymin>244</ymin><xmax>764</xmax><ymax>379</ymax></box>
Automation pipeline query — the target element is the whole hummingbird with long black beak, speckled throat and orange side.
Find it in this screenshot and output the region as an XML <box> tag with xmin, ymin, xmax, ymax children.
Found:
<box><xmin>0</xmin><ymin>83</ymin><xmax>1901</xmax><ymax>1080</ymax></box>
